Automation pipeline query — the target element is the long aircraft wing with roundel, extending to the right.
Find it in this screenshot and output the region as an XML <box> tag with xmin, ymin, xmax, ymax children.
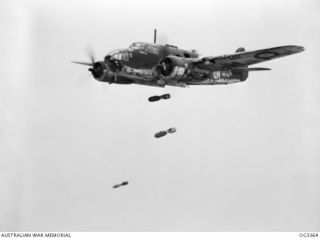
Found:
<box><xmin>194</xmin><ymin>45</ymin><xmax>304</xmax><ymax>70</ymax></box>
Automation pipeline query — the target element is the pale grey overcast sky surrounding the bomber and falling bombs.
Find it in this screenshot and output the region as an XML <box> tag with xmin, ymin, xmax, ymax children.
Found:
<box><xmin>0</xmin><ymin>0</ymin><xmax>320</xmax><ymax>231</ymax></box>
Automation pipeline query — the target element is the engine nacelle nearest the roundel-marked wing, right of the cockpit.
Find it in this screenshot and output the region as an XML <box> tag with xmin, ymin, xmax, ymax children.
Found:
<box><xmin>158</xmin><ymin>56</ymin><xmax>191</xmax><ymax>81</ymax></box>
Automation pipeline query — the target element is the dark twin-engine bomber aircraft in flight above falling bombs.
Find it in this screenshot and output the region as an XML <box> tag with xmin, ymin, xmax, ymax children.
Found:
<box><xmin>73</xmin><ymin>30</ymin><xmax>304</xmax><ymax>87</ymax></box>
